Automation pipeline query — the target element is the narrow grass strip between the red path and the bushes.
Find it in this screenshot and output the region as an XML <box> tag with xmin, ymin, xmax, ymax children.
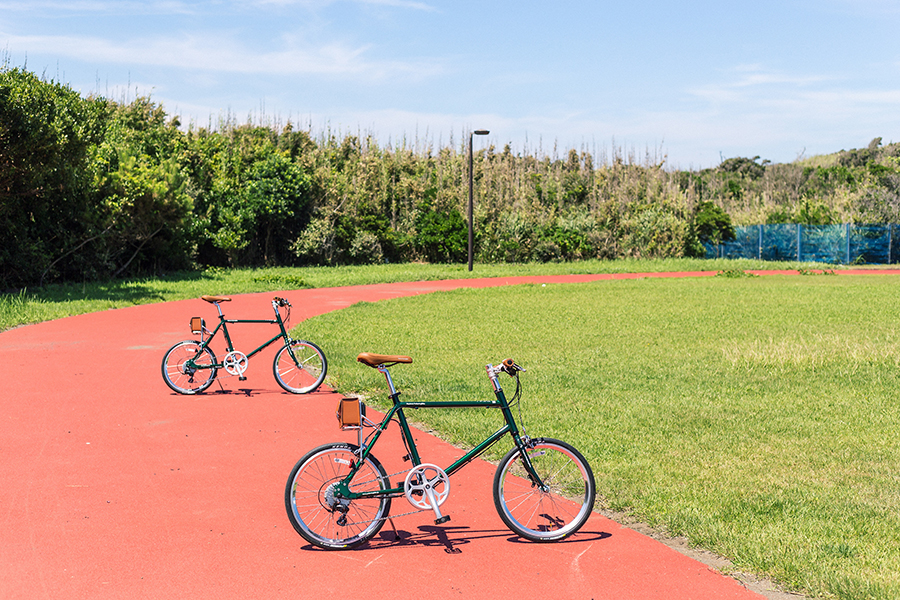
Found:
<box><xmin>0</xmin><ymin>259</ymin><xmax>822</xmax><ymax>331</ymax></box>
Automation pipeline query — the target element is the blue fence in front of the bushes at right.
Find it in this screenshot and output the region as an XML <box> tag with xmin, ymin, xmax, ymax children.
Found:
<box><xmin>706</xmin><ymin>223</ymin><xmax>900</xmax><ymax>264</ymax></box>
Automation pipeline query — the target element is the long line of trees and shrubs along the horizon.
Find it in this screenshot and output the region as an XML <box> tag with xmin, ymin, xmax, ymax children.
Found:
<box><xmin>0</xmin><ymin>65</ymin><xmax>900</xmax><ymax>289</ymax></box>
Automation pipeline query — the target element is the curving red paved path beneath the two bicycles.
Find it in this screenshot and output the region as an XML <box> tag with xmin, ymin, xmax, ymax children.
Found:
<box><xmin>0</xmin><ymin>272</ymin><xmax>896</xmax><ymax>600</ymax></box>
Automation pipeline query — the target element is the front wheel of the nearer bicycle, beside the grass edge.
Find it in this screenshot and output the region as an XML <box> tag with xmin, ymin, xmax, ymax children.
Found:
<box><xmin>494</xmin><ymin>438</ymin><xmax>596</xmax><ymax>542</ymax></box>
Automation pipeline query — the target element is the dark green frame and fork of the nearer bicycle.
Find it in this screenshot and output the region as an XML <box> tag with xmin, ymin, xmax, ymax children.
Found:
<box><xmin>335</xmin><ymin>388</ymin><xmax>544</xmax><ymax>500</ymax></box>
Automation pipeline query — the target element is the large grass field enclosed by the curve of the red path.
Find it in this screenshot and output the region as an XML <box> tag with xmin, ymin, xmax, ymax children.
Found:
<box><xmin>298</xmin><ymin>275</ymin><xmax>900</xmax><ymax>599</ymax></box>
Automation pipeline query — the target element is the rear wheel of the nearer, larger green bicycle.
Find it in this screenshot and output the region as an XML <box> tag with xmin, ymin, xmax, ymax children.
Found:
<box><xmin>284</xmin><ymin>443</ymin><xmax>391</xmax><ymax>550</ymax></box>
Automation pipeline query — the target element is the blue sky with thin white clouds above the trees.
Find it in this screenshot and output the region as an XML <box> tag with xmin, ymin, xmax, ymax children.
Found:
<box><xmin>0</xmin><ymin>0</ymin><xmax>900</xmax><ymax>168</ymax></box>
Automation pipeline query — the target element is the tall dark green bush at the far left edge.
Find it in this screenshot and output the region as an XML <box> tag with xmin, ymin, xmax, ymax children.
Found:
<box><xmin>0</xmin><ymin>69</ymin><xmax>108</xmax><ymax>286</ymax></box>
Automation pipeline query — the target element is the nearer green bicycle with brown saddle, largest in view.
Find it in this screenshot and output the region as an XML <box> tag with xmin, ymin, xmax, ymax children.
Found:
<box><xmin>284</xmin><ymin>353</ymin><xmax>596</xmax><ymax>549</ymax></box>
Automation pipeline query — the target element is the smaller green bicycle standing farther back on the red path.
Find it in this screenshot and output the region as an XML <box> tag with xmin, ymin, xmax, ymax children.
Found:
<box><xmin>162</xmin><ymin>296</ymin><xmax>328</xmax><ymax>394</ymax></box>
